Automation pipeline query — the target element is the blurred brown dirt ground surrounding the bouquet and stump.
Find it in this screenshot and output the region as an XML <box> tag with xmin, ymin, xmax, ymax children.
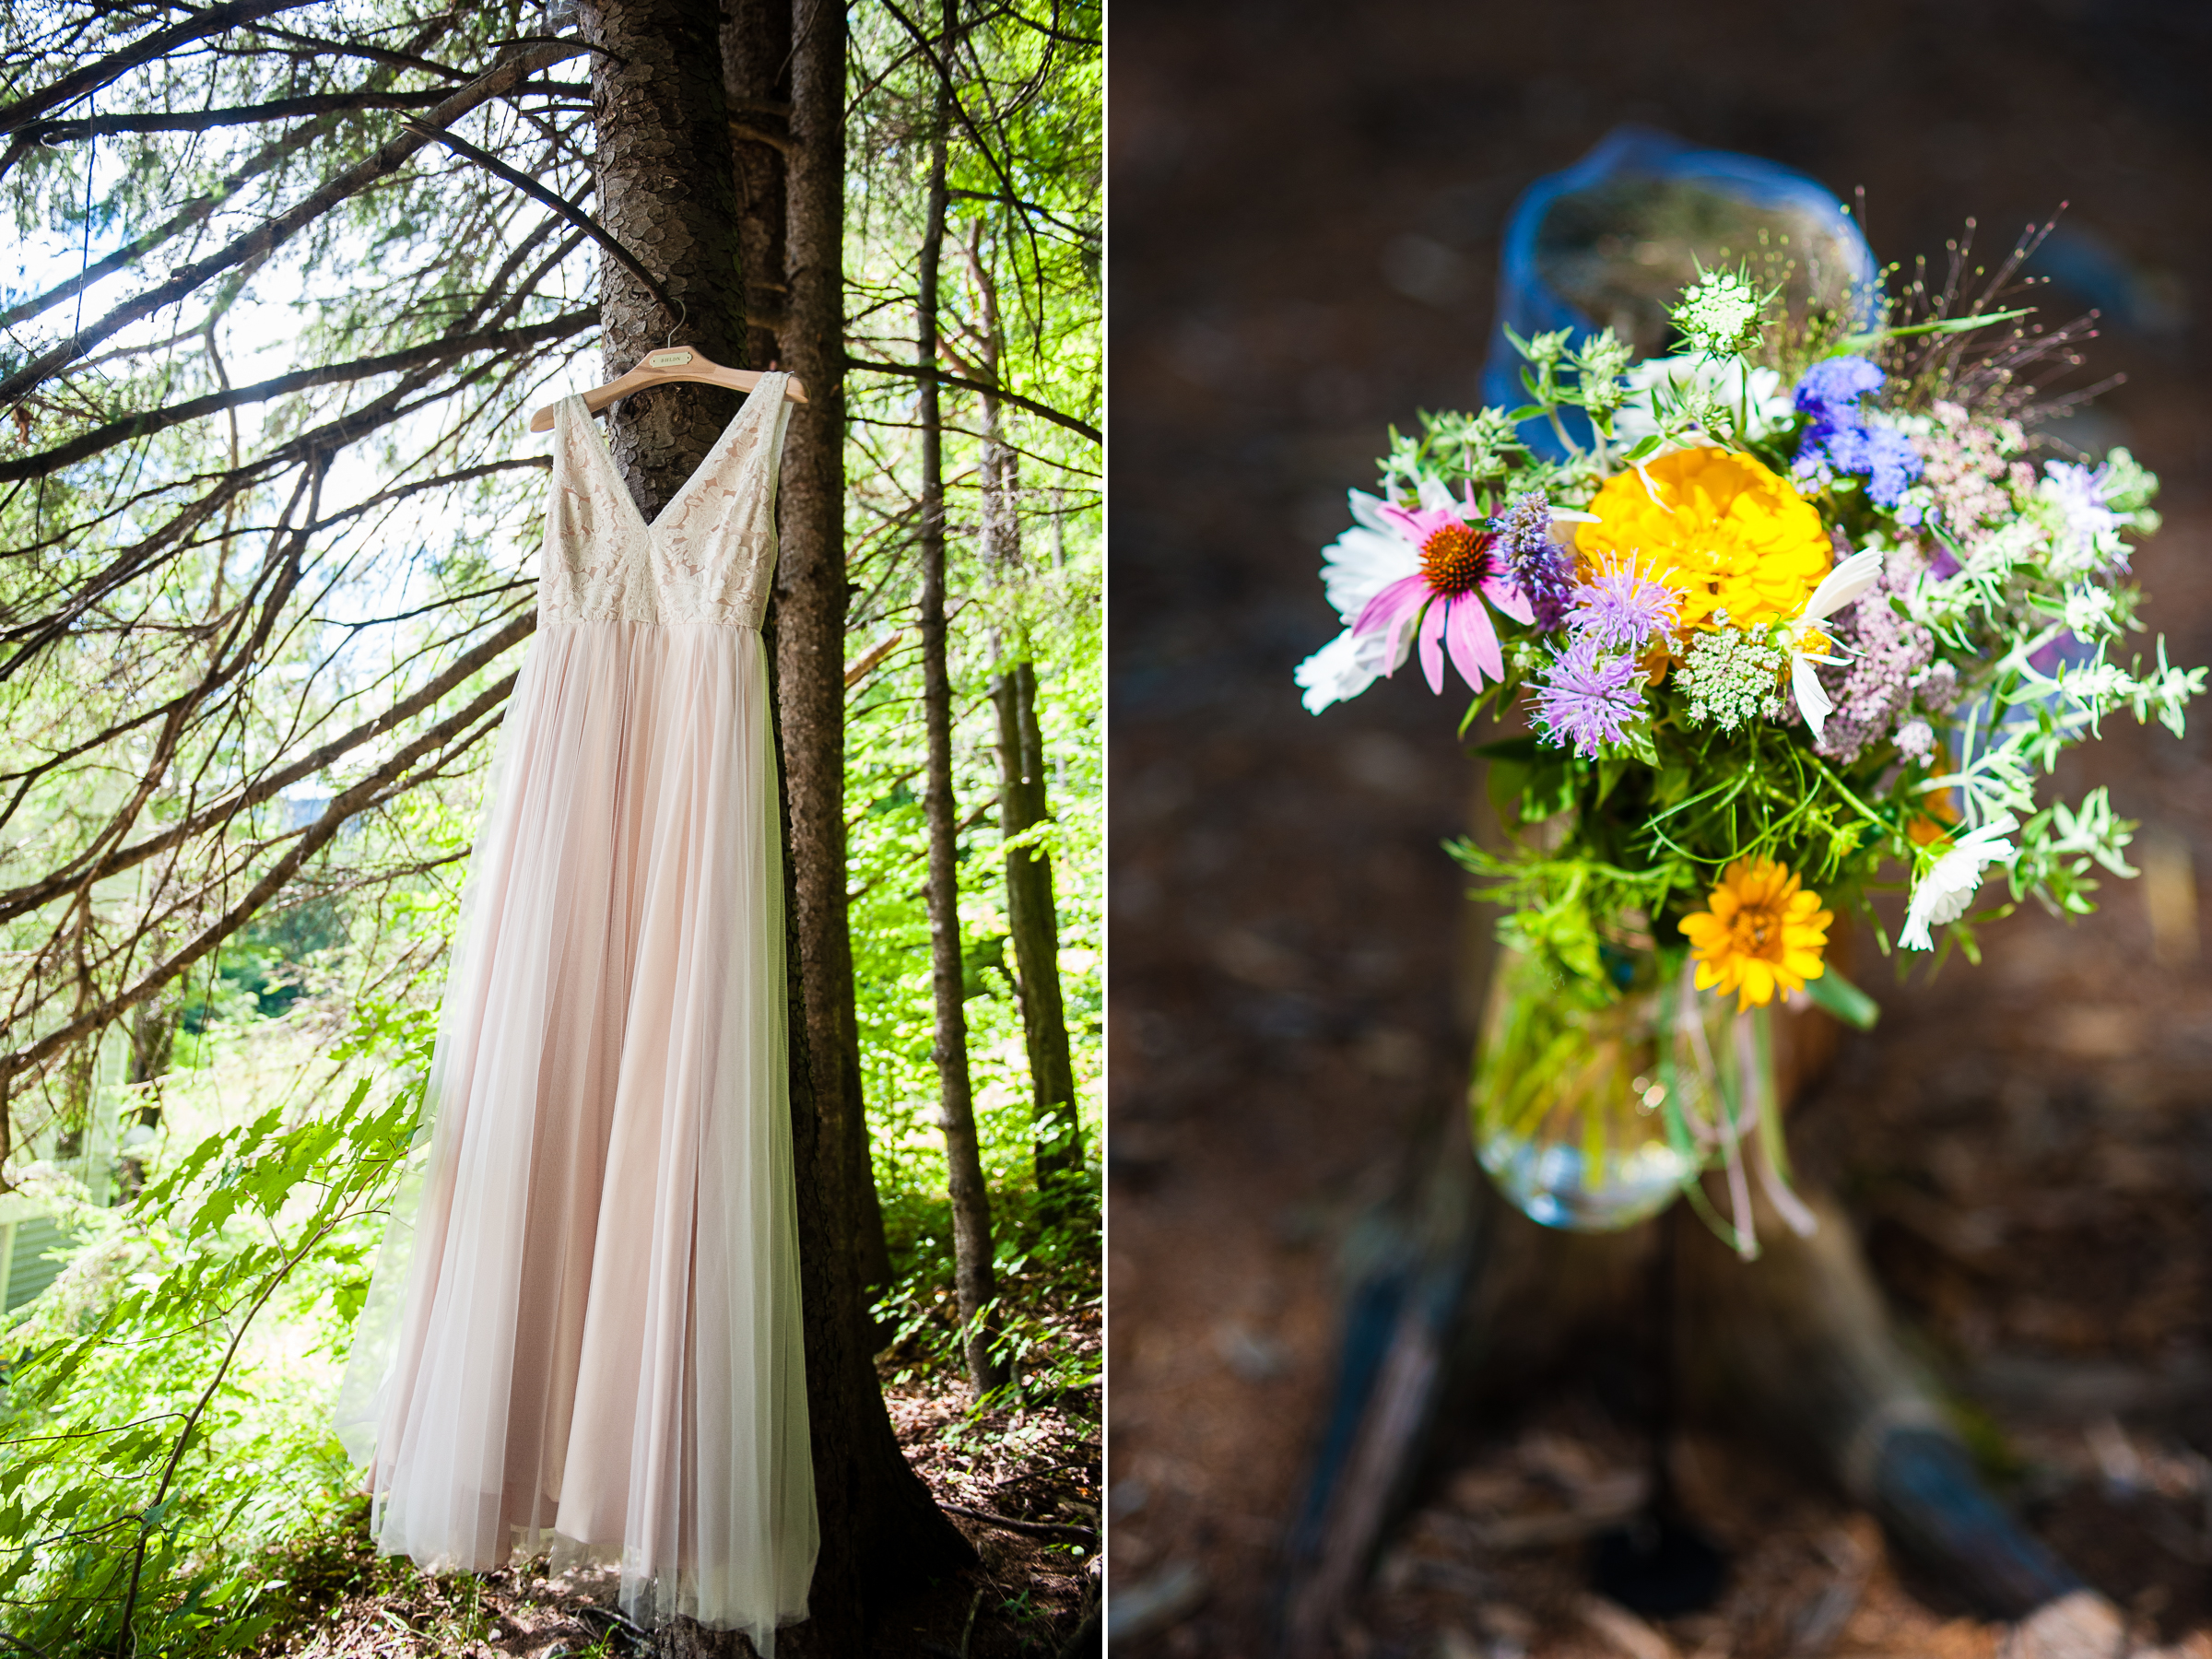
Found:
<box><xmin>1108</xmin><ymin>0</ymin><xmax>2212</xmax><ymax>1659</ymax></box>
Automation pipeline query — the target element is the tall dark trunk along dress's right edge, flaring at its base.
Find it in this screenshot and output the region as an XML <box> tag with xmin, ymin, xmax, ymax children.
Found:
<box><xmin>765</xmin><ymin>0</ymin><xmax>975</xmax><ymax>1659</ymax></box>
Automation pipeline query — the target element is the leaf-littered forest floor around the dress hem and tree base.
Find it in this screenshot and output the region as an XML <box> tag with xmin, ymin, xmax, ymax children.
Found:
<box><xmin>246</xmin><ymin>1378</ymin><xmax>1100</xmax><ymax>1659</ymax></box>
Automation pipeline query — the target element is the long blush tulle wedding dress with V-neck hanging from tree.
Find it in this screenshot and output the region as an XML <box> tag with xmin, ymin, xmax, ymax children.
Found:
<box><xmin>338</xmin><ymin>376</ymin><xmax>818</xmax><ymax>1657</ymax></box>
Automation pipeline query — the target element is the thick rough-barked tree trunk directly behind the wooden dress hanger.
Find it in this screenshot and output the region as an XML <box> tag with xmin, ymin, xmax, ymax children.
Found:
<box><xmin>577</xmin><ymin>0</ymin><xmax>746</xmax><ymax>518</ymax></box>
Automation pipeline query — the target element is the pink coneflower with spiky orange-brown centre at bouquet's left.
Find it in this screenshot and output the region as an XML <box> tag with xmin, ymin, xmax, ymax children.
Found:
<box><xmin>1351</xmin><ymin>498</ymin><xmax>1535</xmax><ymax>692</ymax></box>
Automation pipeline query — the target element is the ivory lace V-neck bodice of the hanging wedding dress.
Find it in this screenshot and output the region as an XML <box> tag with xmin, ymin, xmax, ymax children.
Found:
<box><xmin>537</xmin><ymin>374</ymin><xmax>790</xmax><ymax>629</ymax></box>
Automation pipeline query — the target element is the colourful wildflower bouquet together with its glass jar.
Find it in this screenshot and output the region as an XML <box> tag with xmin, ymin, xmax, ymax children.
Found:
<box><xmin>1296</xmin><ymin>243</ymin><xmax>2206</xmax><ymax>1252</ymax></box>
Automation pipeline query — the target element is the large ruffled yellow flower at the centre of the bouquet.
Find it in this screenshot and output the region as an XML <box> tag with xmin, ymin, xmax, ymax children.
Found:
<box><xmin>1575</xmin><ymin>449</ymin><xmax>1836</xmax><ymax>632</ymax></box>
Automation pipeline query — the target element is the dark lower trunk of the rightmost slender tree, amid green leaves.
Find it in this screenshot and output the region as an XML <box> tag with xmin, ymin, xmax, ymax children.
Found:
<box><xmin>991</xmin><ymin>657</ymin><xmax>1084</xmax><ymax>1221</ymax></box>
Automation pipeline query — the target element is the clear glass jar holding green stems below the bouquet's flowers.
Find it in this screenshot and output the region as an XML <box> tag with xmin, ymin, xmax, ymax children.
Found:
<box><xmin>1471</xmin><ymin>945</ymin><xmax>1771</xmax><ymax>1232</ymax></box>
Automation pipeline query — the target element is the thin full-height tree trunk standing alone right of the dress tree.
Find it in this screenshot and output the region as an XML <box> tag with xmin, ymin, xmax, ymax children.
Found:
<box><xmin>913</xmin><ymin>19</ymin><xmax>1005</xmax><ymax>1398</ymax></box>
